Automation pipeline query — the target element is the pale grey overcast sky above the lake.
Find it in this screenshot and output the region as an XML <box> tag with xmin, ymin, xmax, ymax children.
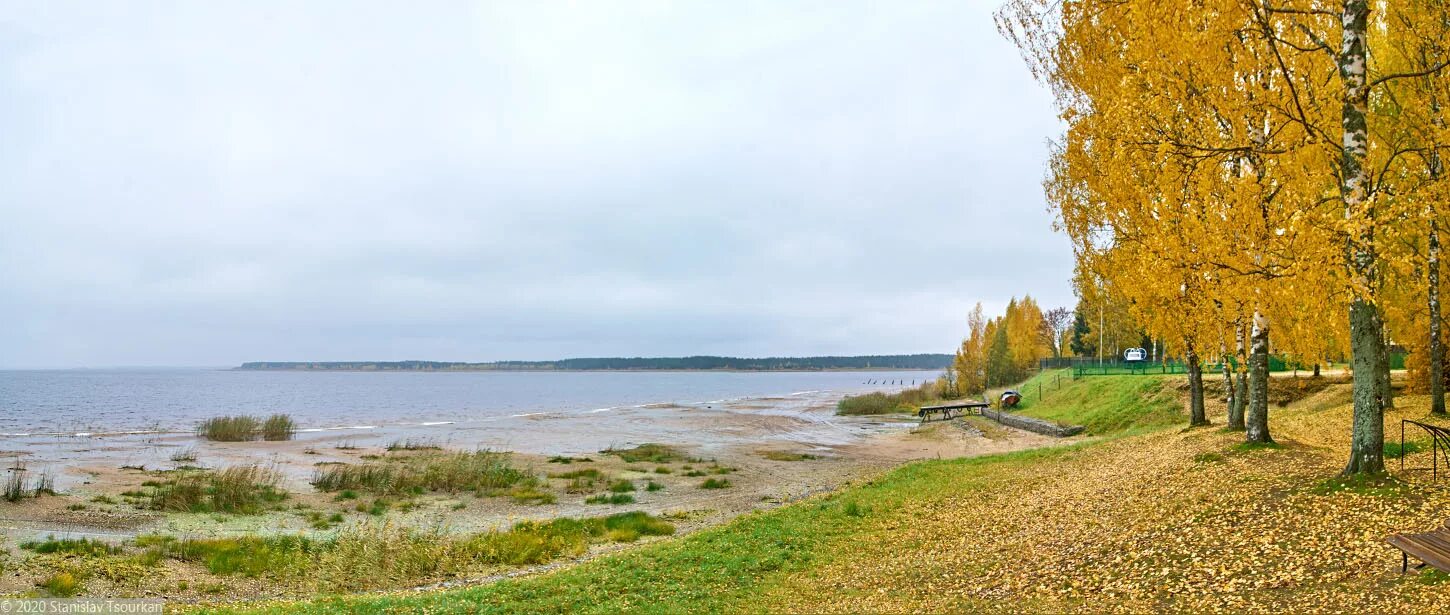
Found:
<box><xmin>0</xmin><ymin>0</ymin><xmax>1073</xmax><ymax>367</ymax></box>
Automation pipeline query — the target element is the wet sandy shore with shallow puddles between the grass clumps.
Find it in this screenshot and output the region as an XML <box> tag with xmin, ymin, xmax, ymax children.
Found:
<box><xmin>0</xmin><ymin>393</ymin><xmax>1061</xmax><ymax>599</ymax></box>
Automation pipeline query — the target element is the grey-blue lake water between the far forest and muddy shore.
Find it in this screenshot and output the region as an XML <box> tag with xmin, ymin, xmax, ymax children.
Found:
<box><xmin>0</xmin><ymin>368</ymin><xmax>937</xmax><ymax>437</ymax></box>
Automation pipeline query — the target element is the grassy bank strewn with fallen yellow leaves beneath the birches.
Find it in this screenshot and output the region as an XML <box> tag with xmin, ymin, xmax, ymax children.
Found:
<box><xmin>207</xmin><ymin>377</ymin><xmax>1450</xmax><ymax>612</ymax></box>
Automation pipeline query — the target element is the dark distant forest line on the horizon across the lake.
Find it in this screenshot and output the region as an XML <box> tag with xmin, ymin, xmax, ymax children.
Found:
<box><xmin>239</xmin><ymin>354</ymin><xmax>956</xmax><ymax>371</ymax></box>
